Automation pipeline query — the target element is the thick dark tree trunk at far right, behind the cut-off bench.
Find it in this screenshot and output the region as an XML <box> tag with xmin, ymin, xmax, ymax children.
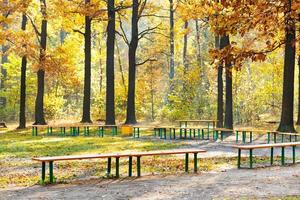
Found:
<box><xmin>278</xmin><ymin>0</ymin><xmax>296</xmax><ymax>132</ymax></box>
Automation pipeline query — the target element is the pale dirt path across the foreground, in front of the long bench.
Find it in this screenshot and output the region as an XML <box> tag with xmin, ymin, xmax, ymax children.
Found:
<box><xmin>0</xmin><ymin>164</ymin><xmax>300</xmax><ymax>200</ymax></box>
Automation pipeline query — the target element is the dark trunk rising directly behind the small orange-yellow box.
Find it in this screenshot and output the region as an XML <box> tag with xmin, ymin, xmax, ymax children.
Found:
<box><xmin>125</xmin><ymin>0</ymin><xmax>139</xmax><ymax>124</ymax></box>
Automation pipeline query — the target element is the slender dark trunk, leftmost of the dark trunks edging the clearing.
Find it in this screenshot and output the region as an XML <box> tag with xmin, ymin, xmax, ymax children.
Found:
<box><xmin>18</xmin><ymin>14</ymin><xmax>27</xmax><ymax>129</ymax></box>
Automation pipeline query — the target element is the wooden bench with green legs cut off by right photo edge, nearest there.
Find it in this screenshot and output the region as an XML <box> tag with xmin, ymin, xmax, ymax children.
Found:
<box><xmin>233</xmin><ymin>142</ymin><xmax>300</xmax><ymax>168</ymax></box>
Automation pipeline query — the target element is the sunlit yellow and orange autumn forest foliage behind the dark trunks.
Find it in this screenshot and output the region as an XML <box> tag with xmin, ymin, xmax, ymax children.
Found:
<box><xmin>0</xmin><ymin>0</ymin><xmax>298</xmax><ymax>128</ymax></box>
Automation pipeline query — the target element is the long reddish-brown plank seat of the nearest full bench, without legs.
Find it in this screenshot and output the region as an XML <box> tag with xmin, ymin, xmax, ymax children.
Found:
<box><xmin>32</xmin><ymin>149</ymin><xmax>206</xmax><ymax>162</ymax></box>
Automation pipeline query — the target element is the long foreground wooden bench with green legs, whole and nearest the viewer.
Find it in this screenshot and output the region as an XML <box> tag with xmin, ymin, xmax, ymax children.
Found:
<box><xmin>32</xmin><ymin>149</ymin><xmax>206</xmax><ymax>183</ymax></box>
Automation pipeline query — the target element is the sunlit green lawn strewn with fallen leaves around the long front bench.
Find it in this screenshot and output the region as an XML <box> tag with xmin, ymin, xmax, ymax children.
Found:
<box><xmin>0</xmin><ymin>129</ymin><xmax>234</xmax><ymax>188</ymax></box>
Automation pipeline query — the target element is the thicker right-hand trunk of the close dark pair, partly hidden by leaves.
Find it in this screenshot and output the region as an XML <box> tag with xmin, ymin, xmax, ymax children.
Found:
<box><xmin>220</xmin><ymin>35</ymin><xmax>233</xmax><ymax>129</ymax></box>
